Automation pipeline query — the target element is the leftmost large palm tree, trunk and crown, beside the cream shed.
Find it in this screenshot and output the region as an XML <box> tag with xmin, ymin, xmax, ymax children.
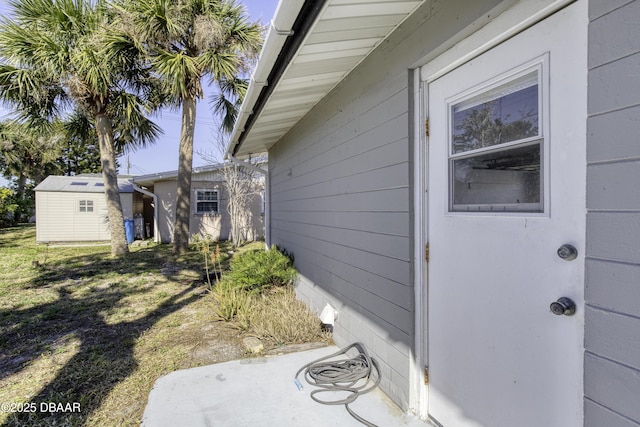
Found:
<box><xmin>0</xmin><ymin>0</ymin><xmax>159</xmax><ymax>255</ymax></box>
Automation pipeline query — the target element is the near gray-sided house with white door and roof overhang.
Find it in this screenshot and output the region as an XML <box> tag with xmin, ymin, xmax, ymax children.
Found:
<box><xmin>227</xmin><ymin>0</ymin><xmax>640</xmax><ymax>427</ymax></box>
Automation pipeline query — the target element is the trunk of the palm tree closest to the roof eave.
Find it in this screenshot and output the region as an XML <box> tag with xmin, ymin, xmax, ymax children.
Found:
<box><xmin>173</xmin><ymin>98</ymin><xmax>196</xmax><ymax>254</ymax></box>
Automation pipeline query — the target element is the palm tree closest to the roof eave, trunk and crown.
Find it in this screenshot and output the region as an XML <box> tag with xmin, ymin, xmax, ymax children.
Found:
<box><xmin>119</xmin><ymin>0</ymin><xmax>262</xmax><ymax>253</ymax></box>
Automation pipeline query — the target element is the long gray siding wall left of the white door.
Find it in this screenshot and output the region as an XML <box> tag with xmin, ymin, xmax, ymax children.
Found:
<box><xmin>269</xmin><ymin>0</ymin><xmax>498</xmax><ymax>409</ymax></box>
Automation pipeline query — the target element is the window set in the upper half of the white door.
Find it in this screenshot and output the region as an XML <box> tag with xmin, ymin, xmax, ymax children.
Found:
<box><xmin>449</xmin><ymin>66</ymin><xmax>544</xmax><ymax>212</ymax></box>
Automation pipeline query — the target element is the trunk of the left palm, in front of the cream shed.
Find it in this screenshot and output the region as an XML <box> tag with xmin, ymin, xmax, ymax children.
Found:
<box><xmin>95</xmin><ymin>114</ymin><xmax>129</xmax><ymax>256</ymax></box>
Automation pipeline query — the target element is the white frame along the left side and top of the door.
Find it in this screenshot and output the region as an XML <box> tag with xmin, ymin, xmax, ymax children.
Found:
<box><xmin>409</xmin><ymin>0</ymin><xmax>587</xmax><ymax>419</ymax></box>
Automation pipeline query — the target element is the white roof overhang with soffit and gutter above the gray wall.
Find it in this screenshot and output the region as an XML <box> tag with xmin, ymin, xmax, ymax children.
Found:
<box><xmin>227</xmin><ymin>0</ymin><xmax>424</xmax><ymax>157</ymax></box>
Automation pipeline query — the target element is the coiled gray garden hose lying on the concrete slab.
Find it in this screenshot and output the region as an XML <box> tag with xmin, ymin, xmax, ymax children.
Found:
<box><xmin>295</xmin><ymin>342</ymin><xmax>380</xmax><ymax>427</ymax></box>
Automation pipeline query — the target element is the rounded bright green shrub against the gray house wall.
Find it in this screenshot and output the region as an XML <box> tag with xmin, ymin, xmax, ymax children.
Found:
<box><xmin>224</xmin><ymin>247</ymin><xmax>298</xmax><ymax>294</ymax></box>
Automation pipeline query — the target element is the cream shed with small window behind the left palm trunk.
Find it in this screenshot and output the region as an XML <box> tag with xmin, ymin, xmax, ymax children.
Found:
<box><xmin>35</xmin><ymin>175</ymin><xmax>142</xmax><ymax>243</ymax></box>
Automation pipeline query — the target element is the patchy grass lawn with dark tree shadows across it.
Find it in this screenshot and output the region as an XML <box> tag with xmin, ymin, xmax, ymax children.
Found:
<box><xmin>0</xmin><ymin>226</ymin><xmax>324</xmax><ymax>426</ymax></box>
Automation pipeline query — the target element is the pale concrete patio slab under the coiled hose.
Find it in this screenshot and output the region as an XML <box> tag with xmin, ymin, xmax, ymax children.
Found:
<box><xmin>142</xmin><ymin>346</ymin><xmax>429</xmax><ymax>427</ymax></box>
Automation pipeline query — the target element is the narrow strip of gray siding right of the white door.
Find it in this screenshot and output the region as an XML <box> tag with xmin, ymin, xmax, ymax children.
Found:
<box><xmin>585</xmin><ymin>0</ymin><xmax>640</xmax><ymax>427</ymax></box>
